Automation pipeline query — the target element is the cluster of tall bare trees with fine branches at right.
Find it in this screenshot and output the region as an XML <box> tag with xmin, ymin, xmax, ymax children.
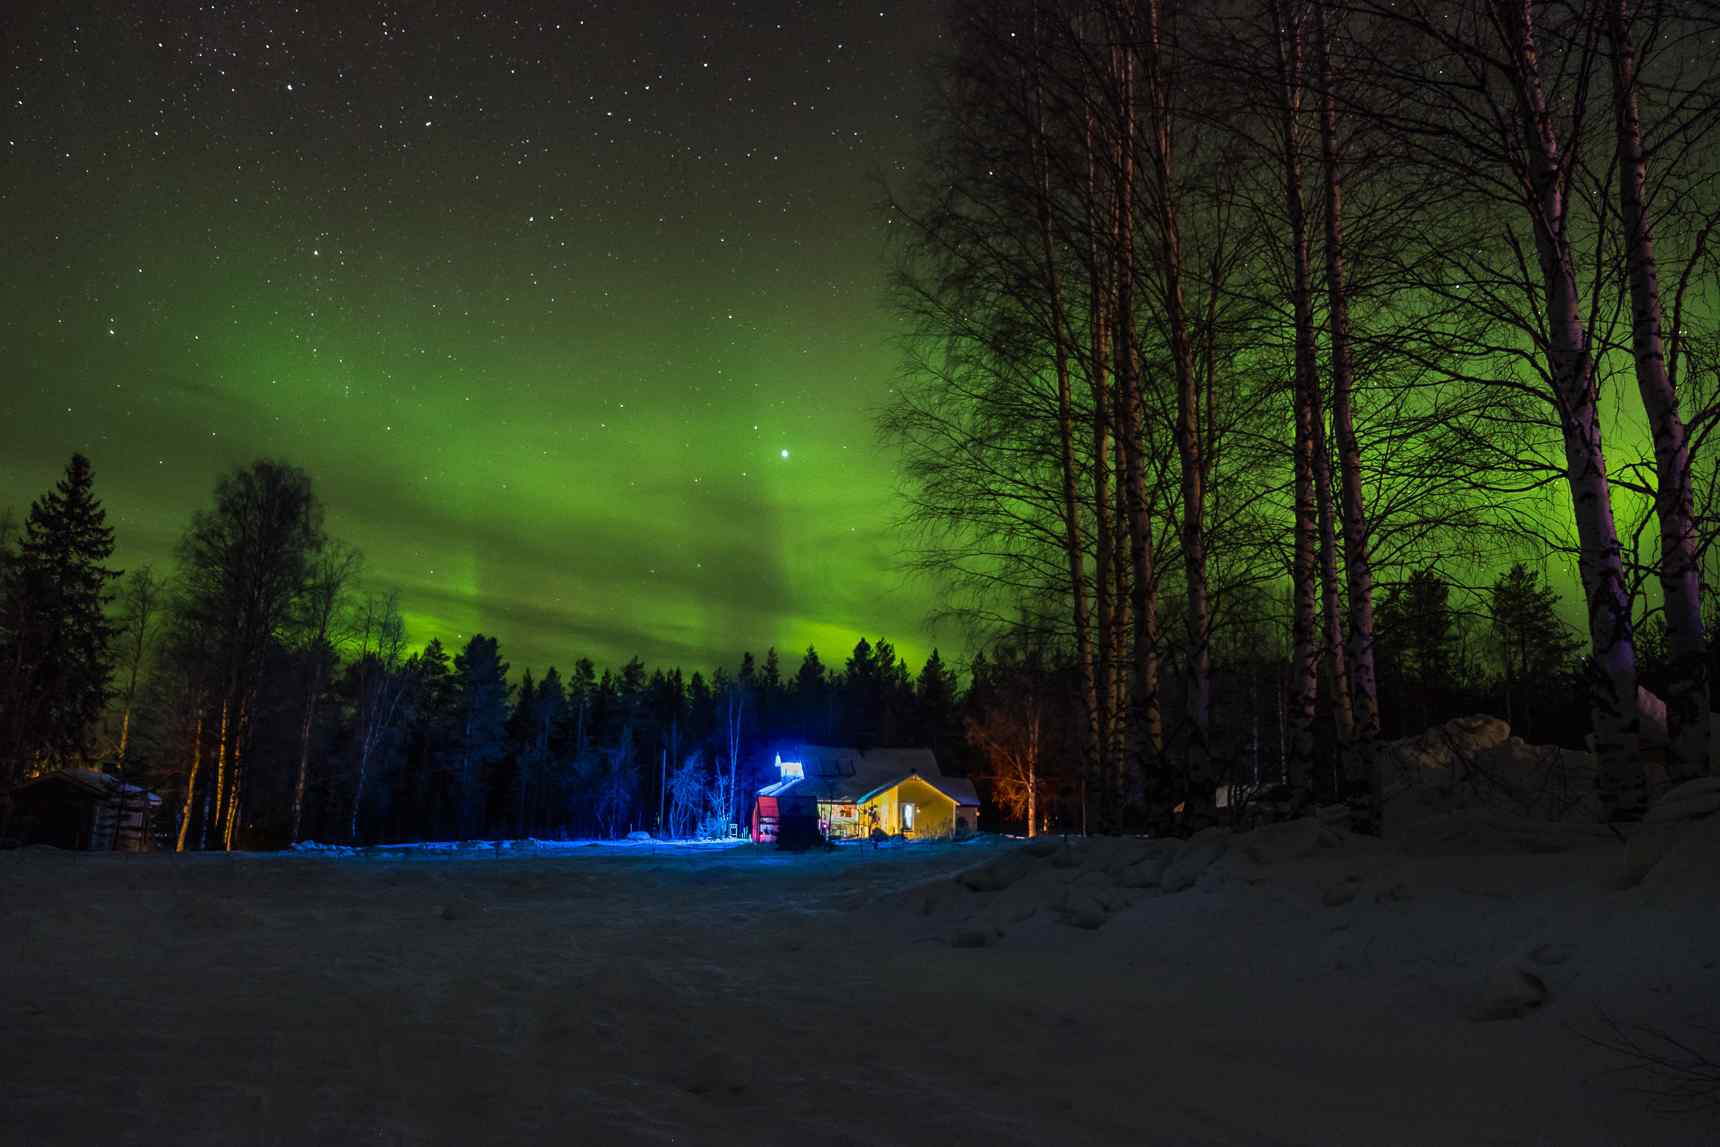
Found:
<box><xmin>884</xmin><ymin>0</ymin><xmax>1720</xmax><ymax>827</ymax></box>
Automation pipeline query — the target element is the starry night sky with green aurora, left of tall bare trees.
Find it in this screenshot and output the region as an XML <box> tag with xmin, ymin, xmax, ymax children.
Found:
<box><xmin>0</xmin><ymin>0</ymin><xmax>949</xmax><ymax>671</ymax></box>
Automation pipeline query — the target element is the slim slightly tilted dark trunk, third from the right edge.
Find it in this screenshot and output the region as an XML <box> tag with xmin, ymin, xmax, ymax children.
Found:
<box><xmin>1314</xmin><ymin>0</ymin><xmax>1379</xmax><ymax>815</ymax></box>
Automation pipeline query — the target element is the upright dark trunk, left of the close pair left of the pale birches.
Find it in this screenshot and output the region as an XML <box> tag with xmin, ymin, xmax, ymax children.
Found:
<box><xmin>1273</xmin><ymin>0</ymin><xmax>1319</xmax><ymax>784</ymax></box>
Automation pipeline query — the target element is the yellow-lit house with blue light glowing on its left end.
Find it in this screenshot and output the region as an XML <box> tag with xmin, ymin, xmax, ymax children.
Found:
<box><xmin>752</xmin><ymin>745</ymin><xmax>979</xmax><ymax>843</ymax></box>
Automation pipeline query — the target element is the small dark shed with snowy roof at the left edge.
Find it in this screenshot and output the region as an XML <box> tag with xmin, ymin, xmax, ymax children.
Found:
<box><xmin>0</xmin><ymin>769</ymin><xmax>162</xmax><ymax>853</ymax></box>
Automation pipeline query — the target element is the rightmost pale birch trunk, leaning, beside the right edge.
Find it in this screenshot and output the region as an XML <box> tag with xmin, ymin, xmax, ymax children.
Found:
<box><xmin>1606</xmin><ymin>0</ymin><xmax>1710</xmax><ymax>781</ymax></box>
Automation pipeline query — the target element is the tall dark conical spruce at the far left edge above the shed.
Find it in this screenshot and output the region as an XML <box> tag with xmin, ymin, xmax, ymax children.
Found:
<box><xmin>0</xmin><ymin>454</ymin><xmax>119</xmax><ymax>779</ymax></box>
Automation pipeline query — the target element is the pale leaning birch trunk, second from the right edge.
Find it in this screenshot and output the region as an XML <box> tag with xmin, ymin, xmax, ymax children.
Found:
<box><xmin>1495</xmin><ymin>0</ymin><xmax>1648</xmax><ymax>819</ymax></box>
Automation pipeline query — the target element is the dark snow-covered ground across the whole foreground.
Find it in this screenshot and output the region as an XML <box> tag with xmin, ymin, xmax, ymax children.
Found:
<box><xmin>0</xmin><ymin>817</ymin><xmax>1720</xmax><ymax>1147</ymax></box>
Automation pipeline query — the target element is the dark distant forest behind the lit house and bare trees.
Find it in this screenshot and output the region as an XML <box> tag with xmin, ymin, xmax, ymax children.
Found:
<box><xmin>0</xmin><ymin>456</ymin><xmax>1678</xmax><ymax>850</ymax></box>
